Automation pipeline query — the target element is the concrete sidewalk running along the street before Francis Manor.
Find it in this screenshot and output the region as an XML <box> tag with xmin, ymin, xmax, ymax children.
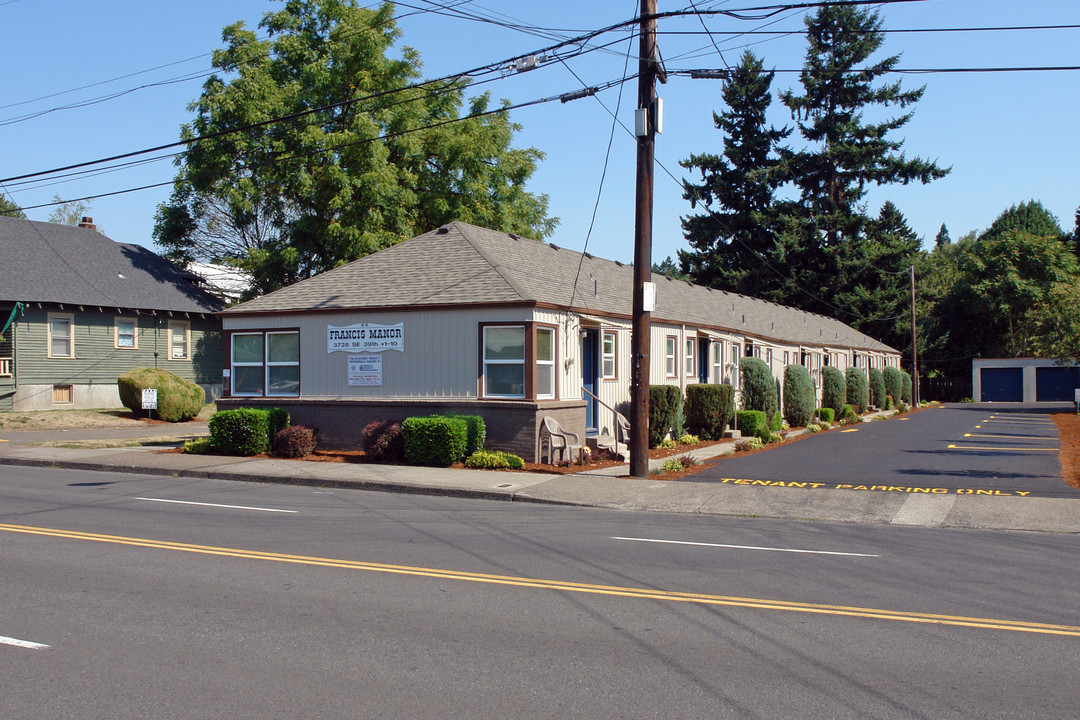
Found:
<box><xmin>0</xmin><ymin>425</ymin><xmax>1080</xmax><ymax>533</ymax></box>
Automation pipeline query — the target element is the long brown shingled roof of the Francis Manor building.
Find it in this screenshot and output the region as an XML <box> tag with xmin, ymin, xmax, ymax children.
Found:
<box><xmin>225</xmin><ymin>222</ymin><xmax>895</xmax><ymax>352</ymax></box>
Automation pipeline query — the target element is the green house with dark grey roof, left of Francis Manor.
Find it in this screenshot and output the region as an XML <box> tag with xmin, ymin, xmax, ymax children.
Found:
<box><xmin>0</xmin><ymin>217</ymin><xmax>222</xmax><ymax>410</ymax></box>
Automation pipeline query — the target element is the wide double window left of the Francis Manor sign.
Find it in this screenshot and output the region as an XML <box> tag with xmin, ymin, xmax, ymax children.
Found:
<box><xmin>230</xmin><ymin>330</ymin><xmax>300</xmax><ymax>397</ymax></box>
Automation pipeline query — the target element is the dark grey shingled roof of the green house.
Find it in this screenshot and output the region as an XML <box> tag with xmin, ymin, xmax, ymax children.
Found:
<box><xmin>0</xmin><ymin>217</ymin><xmax>224</xmax><ymax>313</ymax></box>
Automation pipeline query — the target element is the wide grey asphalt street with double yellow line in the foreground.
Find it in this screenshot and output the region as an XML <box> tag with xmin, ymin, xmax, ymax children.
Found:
<box><xmin>0</xmin><ymin>467</ymin><xmax>1080</xmax><ymax>719</ymax></box>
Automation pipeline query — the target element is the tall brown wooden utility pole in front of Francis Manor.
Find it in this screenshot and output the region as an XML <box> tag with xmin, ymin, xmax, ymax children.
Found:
<box><xmin>630</xmin><ymin>0</ymin><xmax>657</xmax><ymax>477</ymax></box>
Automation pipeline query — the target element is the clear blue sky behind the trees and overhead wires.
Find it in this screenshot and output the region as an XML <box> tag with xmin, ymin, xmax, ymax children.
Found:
<box><xmin>0</xmin><ymin>0</ymin><xmax>1080</xmax><ymax>267</ymax></box>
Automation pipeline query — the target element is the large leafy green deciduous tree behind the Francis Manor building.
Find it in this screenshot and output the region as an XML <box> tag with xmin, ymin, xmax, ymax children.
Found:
<box><xmin>154</xmin><ymin>0</ymin><xmax>557</xmax><ymax>293</ymax></box>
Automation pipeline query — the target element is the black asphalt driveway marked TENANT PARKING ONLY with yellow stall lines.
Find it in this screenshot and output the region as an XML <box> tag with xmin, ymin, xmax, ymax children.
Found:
<box><xmin>694</xmin><ymin>404</ymin><xmax>1080</xmax><ymax>498</ymax></box>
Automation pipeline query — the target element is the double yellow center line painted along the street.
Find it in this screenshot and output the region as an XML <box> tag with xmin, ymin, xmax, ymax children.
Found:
<box><xmin>0</xmin><ymin>524</ymin><xmax>1080</xmax><ymax>638</ymax></box>
